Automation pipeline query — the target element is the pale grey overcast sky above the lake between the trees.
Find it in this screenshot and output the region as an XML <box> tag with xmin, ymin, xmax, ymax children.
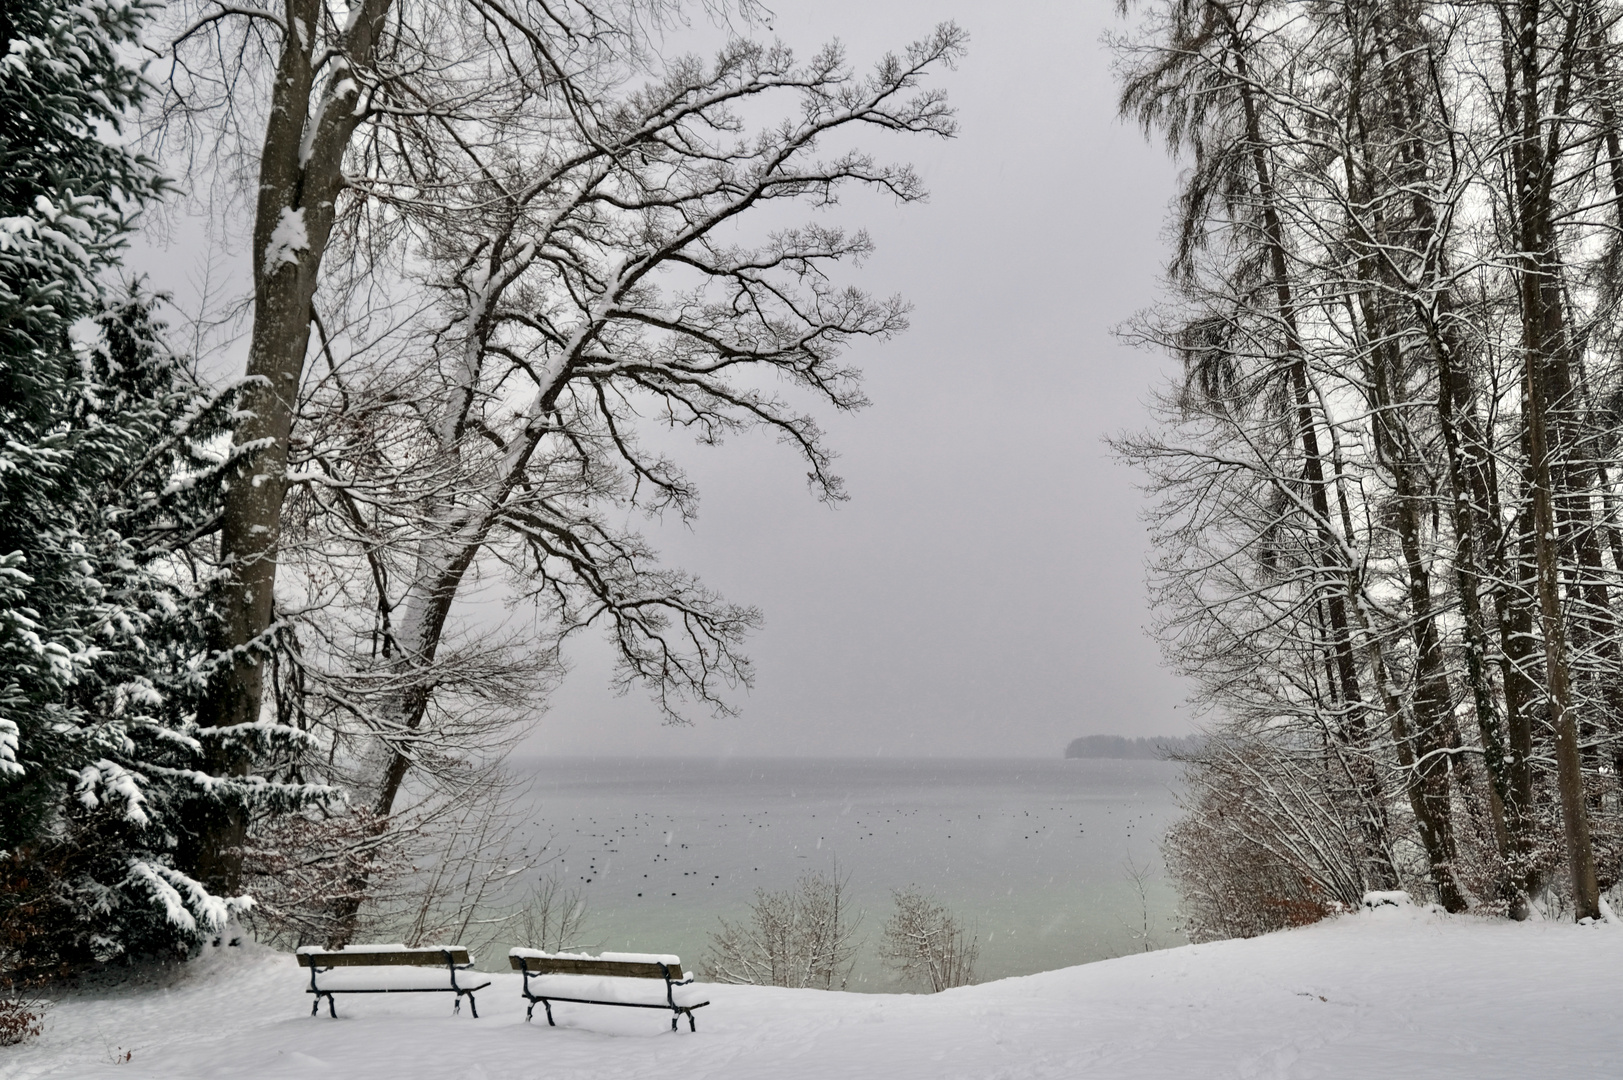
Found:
<box><xmin>531</xmin><ymin>0</ymin><xmax>1190</xmax><ymax>757</ymax></box>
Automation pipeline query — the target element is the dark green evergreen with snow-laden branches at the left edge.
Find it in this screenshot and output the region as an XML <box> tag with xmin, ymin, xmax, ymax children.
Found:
<box><xmin>0</xmin><ymin>0</ymin><xmax>322</xmax><ymax>971</ymax></box>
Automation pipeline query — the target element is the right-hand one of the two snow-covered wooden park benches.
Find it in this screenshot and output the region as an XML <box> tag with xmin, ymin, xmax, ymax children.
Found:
<box><xmin>508</xmin><ymin>948</ymin><xmax>709</xmax><ymax>1031</ymax></box>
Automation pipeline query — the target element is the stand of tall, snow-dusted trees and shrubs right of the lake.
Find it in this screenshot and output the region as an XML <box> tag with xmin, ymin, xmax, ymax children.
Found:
<box><xmin>1115</xmin><ymin>0</ymin><xmax>1623</xmax><ymax>934</ymax></box>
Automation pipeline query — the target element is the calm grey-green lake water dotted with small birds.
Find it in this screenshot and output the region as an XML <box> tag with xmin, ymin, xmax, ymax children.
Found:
<box><xmin>499</xmin><ymin>758</ymin><xmax>1183</xmax><ymax>991</ymax></box>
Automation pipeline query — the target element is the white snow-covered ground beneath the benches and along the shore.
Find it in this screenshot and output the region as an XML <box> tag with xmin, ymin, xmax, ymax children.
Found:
<box><xmin>0</xmin><ymin>908</ymin><xmax>1623</xmax><ymax>1080</ymax></box>
